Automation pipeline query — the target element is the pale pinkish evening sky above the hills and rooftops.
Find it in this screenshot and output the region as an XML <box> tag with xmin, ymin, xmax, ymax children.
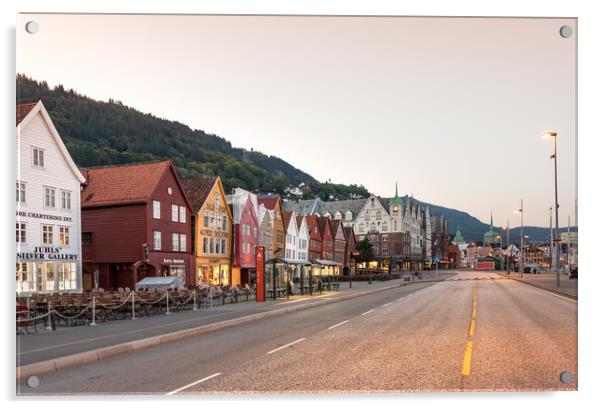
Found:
<box><xmin>17</xmin><ymin>14</ymin><xmax>577</xmax><ymax>227</ymax></box>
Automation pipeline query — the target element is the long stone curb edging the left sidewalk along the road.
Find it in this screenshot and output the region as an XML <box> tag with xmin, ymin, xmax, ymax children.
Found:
<box><xmin>16</xmin><ymin>280</ymin><xmax>442</xmax><ymax>380</ymax></box>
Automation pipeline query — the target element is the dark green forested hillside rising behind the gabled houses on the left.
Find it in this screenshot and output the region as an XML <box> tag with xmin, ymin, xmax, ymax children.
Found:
<box><xmin>17</xmin><ymin>75</ymin><xmax>369</xmax><ymax>199</ymax></box>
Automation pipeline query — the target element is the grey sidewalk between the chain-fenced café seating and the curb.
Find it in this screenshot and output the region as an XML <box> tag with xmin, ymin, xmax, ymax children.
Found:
<box><xmin>17</xmin><ymin>273</ymin><xmax>450</xmax><ymax>372</ymax></box>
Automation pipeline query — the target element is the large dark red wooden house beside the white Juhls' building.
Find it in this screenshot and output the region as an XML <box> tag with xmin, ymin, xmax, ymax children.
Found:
<box><xmin>81</xmin><ymin>161</ymin><xmax>194</xmax><ymax>289</ymax></box>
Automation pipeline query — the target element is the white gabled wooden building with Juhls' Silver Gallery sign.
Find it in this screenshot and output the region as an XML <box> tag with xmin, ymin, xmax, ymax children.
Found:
<box><xmin>16</xmin><ymin>101</ymin><xmax>85</xmax><ymax>293</ymax></box>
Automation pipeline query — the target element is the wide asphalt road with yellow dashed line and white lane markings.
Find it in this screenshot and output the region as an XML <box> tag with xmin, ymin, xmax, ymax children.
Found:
<box><xmin>17</xmin><ymin>272</ymin><xmax>577</xmax><ymax>394</ymax></box>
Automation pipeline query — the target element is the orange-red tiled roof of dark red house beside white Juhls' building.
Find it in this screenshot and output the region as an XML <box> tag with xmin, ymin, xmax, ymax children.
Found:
<box><xmin>81</xmin><ymin>161</ymin><xmax>175</xmax><ymax>208</ymax></box>
